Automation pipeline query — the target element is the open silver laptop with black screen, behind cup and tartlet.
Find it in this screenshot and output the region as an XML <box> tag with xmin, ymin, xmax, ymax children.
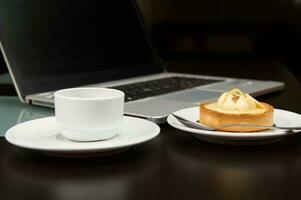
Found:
<box><xmin>0</xmin><ymin>0</ymin><xmax>284</xmax><ymax>123</ymax></box>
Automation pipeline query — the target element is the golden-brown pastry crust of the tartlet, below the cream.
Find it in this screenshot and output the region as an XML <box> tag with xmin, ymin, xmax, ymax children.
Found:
<box><xmin>200</xmin><ymin>102</ymin><xmax>274</xmax><ymax>132</ymax></box>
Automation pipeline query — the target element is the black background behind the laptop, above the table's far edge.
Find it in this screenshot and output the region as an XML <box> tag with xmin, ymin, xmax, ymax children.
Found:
<box><xmin>0</xmin><ymin>0</ymin><xmax>301</xmax><ymax>80</ymax></box>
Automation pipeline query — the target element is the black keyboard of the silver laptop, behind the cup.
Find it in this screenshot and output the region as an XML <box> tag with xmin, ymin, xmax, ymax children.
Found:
<box><xmin>111</xmin><ymin>77</ymin><xmax>221</xmax><ymax>102</ymax></box>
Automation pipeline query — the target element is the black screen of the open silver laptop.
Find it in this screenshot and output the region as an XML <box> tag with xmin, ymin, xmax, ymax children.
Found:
<box><xmin>0</xmin><ymin>0</ymin><xmax>163</xmax><ymax>95</ymax></box>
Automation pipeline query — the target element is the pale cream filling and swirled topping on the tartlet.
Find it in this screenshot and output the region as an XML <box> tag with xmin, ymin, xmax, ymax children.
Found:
<box><xmin>206</xmin><ymin>89</ymin><xmax>266</xmax><ymax>114</ymax></box>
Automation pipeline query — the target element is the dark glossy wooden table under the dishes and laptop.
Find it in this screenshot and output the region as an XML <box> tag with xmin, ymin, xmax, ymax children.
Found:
<box><xmin>0</xmin><ymin>61</ymin><xmax>301</xmax><ymax>200</ymax></box>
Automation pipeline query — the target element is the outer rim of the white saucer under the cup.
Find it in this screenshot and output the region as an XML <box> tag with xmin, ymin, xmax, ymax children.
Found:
<box><xmin>5</xmin><ymin>116</ymin><xmax>161</xmax><ymax>153</ymax></box>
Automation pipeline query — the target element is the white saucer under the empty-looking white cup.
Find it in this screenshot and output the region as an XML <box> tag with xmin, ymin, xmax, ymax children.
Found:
<box><xmin>5</xmin><ymin>116</ymin><xmax>160</xmax><ymax>156</ymax></box>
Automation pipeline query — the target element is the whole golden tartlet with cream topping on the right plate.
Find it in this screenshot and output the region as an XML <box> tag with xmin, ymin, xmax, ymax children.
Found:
<box><xmin>199</xmin><ymin>89</ymin><xmax>274</xmax><ymax>132</ymax></box>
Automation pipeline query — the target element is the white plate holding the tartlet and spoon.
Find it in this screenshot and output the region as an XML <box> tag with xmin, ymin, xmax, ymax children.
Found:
<box><xmin>167</xmin><ymin>107</ymin><xmax>301</xmax><ymax>145</ymax></box>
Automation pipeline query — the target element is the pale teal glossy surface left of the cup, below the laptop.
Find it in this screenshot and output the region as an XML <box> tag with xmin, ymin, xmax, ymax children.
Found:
<box><xmin>0</xmin><ymin>96</ymin><xmax>54</xmax><ymax>136</ymax></box>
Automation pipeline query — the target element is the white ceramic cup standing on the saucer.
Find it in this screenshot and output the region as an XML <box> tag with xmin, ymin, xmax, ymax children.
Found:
<box><xmin>54</xmin><ymin>88</ymin><xmax>124</xmax><ymax>141</ymax></box>
